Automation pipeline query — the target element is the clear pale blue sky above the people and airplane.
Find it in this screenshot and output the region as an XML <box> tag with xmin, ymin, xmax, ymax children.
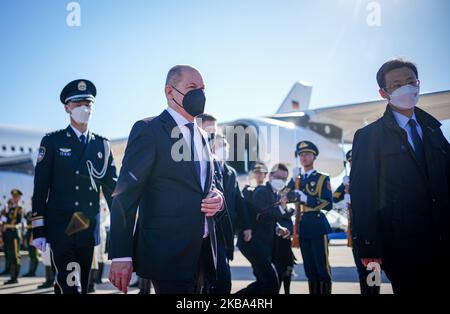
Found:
<box><xmin>0</xmin><ymin>0</ymin><xmax>450</xmax><ymax>138</ymax></box>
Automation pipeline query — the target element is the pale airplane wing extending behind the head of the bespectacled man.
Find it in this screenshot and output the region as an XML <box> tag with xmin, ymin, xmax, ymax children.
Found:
<box><xmin>306</xmin><ymin>91</ymin><xmax>450</xmax><ymax>143</ymax></box>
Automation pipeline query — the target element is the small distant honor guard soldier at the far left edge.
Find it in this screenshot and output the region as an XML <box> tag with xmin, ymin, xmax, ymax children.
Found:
<box><xmin>3</xmin><ymin>189</ymin><xmax>23</xmax><ymax>285</ymax></box>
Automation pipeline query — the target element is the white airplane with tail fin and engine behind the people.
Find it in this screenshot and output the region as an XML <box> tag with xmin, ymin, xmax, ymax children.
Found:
<box><xmin>0</xmin><ymin>82</ymin><xmax>450</xmax><ymax>228</ymax></box>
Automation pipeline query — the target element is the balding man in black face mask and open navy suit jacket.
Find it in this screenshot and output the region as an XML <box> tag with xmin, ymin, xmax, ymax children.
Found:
<box><xmin>109</xmin><ymin>66</ymin><xmax>223</xmax><ymax>294</ymax></box>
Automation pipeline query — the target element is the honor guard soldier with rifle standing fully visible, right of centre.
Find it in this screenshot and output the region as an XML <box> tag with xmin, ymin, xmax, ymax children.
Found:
<box><xmin>288</xmin><ymin>141</ymin><xmax>333</xmax><ymax>294</ymax></box>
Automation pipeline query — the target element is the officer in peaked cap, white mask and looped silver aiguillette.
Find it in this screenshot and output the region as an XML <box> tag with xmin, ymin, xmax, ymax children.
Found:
<box><xmin>32</xmin><ymin>80</ymin><xmax>117</xmax><ymax>294</ymax></box>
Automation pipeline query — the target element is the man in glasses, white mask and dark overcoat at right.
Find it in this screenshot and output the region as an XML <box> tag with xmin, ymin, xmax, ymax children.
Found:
<box><xmin>350</xmin><ymin>59</ymin><xmax>450</xmax><ymax>294</ymax></box>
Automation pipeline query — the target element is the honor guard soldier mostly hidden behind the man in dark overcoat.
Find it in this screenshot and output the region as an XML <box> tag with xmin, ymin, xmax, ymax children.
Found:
<box><xmin>333</xmin><ymin>150</ymin><xmax>380</xmax><ymax>295</ymax></box>
